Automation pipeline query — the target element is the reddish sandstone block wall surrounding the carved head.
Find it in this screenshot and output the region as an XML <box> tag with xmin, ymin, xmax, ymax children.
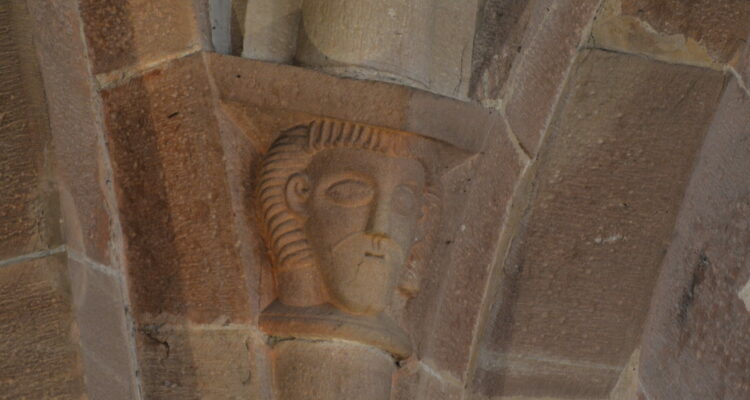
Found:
<box><xmin>0</xmin><ymin>0</ymin><xmax>750</xmax><ymax>400</ymax></box>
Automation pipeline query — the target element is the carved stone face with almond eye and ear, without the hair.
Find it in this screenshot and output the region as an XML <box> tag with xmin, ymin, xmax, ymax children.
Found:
<box><xmin>285</xmin><ymin>148</ymin><xmax>426</xmax><ymax>314</ymax></box>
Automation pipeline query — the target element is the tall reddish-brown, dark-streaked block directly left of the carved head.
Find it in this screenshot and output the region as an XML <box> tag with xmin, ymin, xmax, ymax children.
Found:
<box><xmin>102</xmin><ymin>55</ymin><xmax>249</xmax><ymax>322</ymax></box>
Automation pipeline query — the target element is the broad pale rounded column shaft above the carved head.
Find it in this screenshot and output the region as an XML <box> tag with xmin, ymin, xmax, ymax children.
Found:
<box><xmin>296</xmin><ymin>0</ymin><xmax>434</xmax><ymax>88</ymax></box>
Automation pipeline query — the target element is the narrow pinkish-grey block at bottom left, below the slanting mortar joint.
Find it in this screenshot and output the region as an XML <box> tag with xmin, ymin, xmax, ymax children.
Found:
<box><xmin>68</xmin><ymin>258</ymin><xmax>136</xmax><ymax>400</ymax></box>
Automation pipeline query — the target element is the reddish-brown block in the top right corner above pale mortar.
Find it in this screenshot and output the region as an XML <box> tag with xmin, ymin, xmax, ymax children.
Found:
<box><xmin>593</xmin><ymin>0</ymin><xmax>750</xmax><ymax>68</ymax></box>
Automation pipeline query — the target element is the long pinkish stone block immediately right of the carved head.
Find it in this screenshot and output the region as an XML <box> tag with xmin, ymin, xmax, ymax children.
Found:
<box><xmin>403</xmin><ymin>117</ymin><xmax>522</xmax><ymax>381</ymax></box>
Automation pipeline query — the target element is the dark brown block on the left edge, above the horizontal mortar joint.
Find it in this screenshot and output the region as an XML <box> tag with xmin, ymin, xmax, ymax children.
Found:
<box><xmin>0</xmin><ymin>0</ymin><xmax>60</xmax><ymax>260</ymax></box>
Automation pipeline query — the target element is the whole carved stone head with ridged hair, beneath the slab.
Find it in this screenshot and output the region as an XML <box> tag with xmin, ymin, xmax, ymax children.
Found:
<box><xmin>259</xmin><ymin>120</ymin><xmax>434</xmax><ymax>315</ymax></box>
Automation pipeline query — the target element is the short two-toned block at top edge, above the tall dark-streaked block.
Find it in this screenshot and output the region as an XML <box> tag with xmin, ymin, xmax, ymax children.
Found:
<box><xmin>80</xmin><ymin>0</ymin><xmax>201</xmax><ymax>74</ymax></box>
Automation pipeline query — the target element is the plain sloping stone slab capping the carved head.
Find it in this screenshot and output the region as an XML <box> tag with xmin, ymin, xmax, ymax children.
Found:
<box><xmin>205</xmin><ymin>53</ymin><xmax>498</xmax><ymax>156</ymax></box>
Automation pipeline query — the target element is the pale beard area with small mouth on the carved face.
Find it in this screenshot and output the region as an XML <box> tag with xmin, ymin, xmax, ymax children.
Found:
<box><xmin>321</xmin><ymin>233</ymin><xmax>406</xmax><ymax>314</ymax></box>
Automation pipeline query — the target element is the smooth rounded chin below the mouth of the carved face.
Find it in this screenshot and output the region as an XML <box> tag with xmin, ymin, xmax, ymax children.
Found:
<box><xmin>323</xmin><ymin>251</ymin><xmax>402</xmax><ymax>314</ymax></box>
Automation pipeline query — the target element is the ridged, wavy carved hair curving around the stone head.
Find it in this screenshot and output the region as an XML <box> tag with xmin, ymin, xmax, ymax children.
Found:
<box><xmin>258</xmin><ymin>119</ymin><xmax>439</xmax><ymax>278</ymax></box>
